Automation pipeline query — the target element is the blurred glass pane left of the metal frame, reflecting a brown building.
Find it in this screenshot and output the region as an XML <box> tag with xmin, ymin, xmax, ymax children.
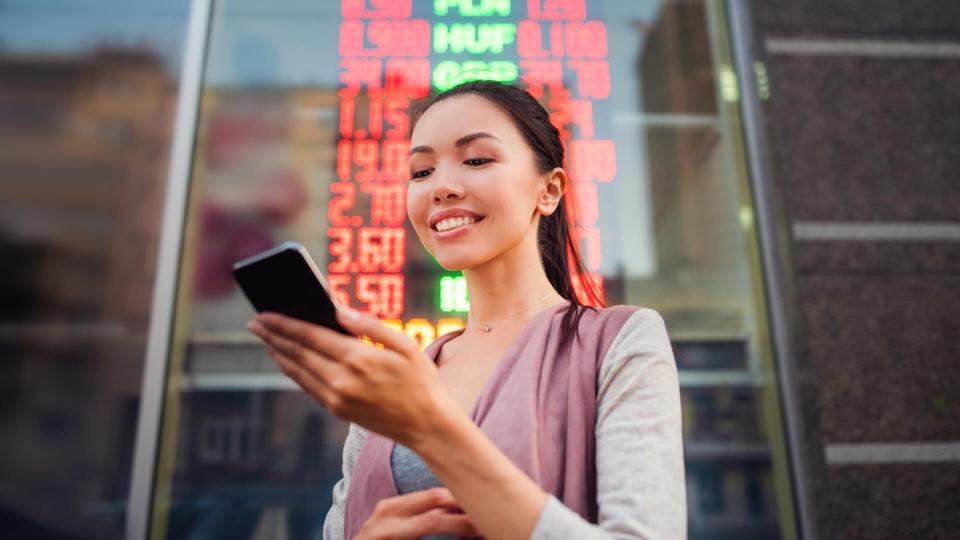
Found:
<box><xmin>0</xmin><ymin>0</ymin><xmax>188</xmax><ymax>538</ymax></box>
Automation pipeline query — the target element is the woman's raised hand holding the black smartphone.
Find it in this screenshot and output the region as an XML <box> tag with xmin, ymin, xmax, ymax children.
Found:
<box><xmin>247</xmin><ymin>309</ymin><xmax>451</xmax><ymax>446</ymax></box>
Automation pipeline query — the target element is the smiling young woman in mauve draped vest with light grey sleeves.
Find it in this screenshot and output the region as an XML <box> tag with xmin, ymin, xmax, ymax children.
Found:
<box><xmin>249</xmin><ymin>82</ymin><xmax>686</xmax><ymax>539</ymax></box>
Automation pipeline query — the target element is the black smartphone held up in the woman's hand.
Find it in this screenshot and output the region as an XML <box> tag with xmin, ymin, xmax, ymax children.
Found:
<box><xmin>233</xmin><ymin>242</ymin><xmax>351</xmax><ymax>335</ymax></box>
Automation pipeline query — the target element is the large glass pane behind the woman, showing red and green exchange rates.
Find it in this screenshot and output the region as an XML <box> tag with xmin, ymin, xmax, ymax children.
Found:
<box><xmin>153</xmin><ymin>0</ymin><xmax>793</xmax><ymax>538</ymax></box>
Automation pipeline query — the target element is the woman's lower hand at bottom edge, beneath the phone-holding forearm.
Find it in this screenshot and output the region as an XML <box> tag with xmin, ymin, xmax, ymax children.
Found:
<box><xmin>354</xmin><ymin>488</ymin><xmax>478</xmax><ymax>540</ymax></box>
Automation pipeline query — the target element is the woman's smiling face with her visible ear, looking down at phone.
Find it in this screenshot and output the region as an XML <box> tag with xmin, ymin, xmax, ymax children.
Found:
<box><xmin>407</xmin><ymin>94</ymin><xmax>562</xmax><ymax>270</ymax></box>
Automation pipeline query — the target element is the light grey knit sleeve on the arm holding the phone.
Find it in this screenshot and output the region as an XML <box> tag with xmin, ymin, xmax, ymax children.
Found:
<box><xmin>531</xmin><ymin>309</ymin><xmax>687</xmax><ymax>540</ymax></box>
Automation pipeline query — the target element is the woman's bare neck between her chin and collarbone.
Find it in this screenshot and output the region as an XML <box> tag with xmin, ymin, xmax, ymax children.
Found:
<box><xmin>463</xmin><ymin>221</ymin><xmax>565</xmax><ymax>326</ymax></box>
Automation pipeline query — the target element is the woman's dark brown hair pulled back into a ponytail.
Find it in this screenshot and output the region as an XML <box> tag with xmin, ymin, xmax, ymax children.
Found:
<box><xmin>411</xmin><ymin>81</ymin><xmax>604</xmax><ymax>346</ymax></box>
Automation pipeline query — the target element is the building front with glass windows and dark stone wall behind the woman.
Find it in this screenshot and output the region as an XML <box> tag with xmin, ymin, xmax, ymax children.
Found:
<box><xmin>0</xmin><ymin>0</ymin><xmax>960</xmax><ymax>539</ymax></box>
